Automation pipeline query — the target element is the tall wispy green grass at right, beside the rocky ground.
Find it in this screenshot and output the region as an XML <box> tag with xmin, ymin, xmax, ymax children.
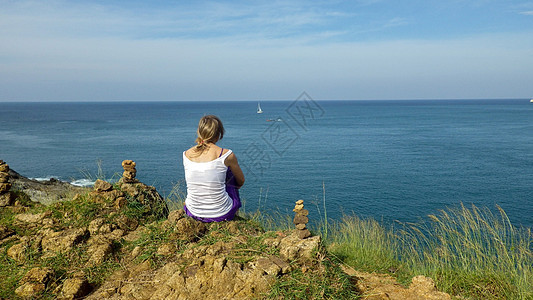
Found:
<box><xmin>328</xmin><ymin>205</ymin><xmax>533</xmax><ymax>299</ymax></box>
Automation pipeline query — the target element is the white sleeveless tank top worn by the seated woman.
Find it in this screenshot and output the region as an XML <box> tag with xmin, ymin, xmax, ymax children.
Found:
<box><xmin>183</xmin><ymin>150</ymin><xmax>233</xmax><ymax>218</ymax></box>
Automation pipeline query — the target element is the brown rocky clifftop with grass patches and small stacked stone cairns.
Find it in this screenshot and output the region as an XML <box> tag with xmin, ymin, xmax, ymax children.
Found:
<box><xmin>0</xmin><ymin>161</ymin><xmax>449</xmax><ymax>299</ymax></box>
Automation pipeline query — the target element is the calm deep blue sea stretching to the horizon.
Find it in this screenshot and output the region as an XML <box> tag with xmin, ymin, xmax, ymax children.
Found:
<box><xmin>0</xmin><ymin>98</ymin><xmax>533</xmax><ymax>227</ymax></box>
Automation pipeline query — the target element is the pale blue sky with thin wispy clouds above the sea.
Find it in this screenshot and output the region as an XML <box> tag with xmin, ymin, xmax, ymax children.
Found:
<box><xmin>0</xmin><ymin>0</ymin><xmax>533</xmax><ymax>101</ymax></box>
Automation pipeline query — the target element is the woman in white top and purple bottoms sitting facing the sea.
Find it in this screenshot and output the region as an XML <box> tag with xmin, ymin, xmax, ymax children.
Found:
<box><xmin>183</xmin><ymin>115</ymin><xmax>244</xmax><ymax>222</ymax></box>
